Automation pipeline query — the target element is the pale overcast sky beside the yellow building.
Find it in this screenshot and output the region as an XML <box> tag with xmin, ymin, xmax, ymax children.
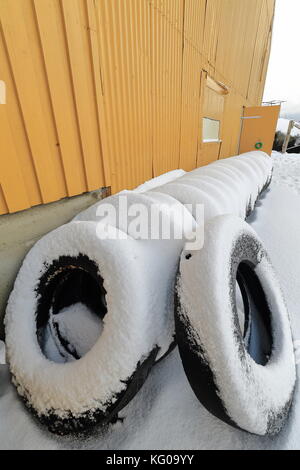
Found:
<box><xmin>264</xmin><ymin>0</ymin><xmax>300</xmax><ymax>120</ymax></box>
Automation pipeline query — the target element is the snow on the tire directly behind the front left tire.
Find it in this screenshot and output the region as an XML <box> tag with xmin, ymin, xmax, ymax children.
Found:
<box><xmin>74</xmin><ymin>190</ymin><xmax>196</xmax><ymax>361</ymax></box>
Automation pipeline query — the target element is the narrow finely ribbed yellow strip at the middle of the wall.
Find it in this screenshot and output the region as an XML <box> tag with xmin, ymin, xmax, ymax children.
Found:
<box><xmin>151</xmin><ymin>1</ymin><xmax>182</xmax><ymax>176</ymax></box>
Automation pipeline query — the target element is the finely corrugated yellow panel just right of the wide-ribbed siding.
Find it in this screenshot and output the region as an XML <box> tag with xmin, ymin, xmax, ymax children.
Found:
<box><xmin>97</xmin><ymin>0</ymin><xmax>152</xmax><ymax>192</ymax></box>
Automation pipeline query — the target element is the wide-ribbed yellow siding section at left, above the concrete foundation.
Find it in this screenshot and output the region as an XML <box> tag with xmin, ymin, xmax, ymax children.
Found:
<box><xmin>0</xmin><ymin>0</ymin><xmax>109</xmax><ymax>213</ymax></box>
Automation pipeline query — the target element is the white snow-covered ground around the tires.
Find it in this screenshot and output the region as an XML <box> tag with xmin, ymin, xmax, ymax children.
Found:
<box><xmin>0</xmin><ymin>154</ymin><xmax>300</xmax><ymax>449</ymax></box>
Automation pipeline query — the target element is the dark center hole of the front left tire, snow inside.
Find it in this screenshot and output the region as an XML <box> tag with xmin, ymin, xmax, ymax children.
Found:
<box><xmin>36</xmin><ymin>257</ymin><xmax>107</xmax><ymax>362</ymax></box>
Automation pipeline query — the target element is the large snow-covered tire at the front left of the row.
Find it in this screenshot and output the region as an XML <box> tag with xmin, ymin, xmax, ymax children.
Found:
<box><xmin>5</xmin><ymin>222</ymin><xmax>172</xmax><ymax>434</ymax></box>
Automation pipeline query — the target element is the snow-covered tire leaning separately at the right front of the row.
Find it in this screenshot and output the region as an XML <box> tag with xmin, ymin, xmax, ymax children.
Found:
<box><xmin>175</xmin><ymin>215</ymin><xmax>295</xmax><ymax>435</ymax></box>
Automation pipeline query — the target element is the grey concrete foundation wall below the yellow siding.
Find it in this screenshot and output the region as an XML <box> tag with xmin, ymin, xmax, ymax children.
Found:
<box><xmin>0</xmin><ymin>188</ymin><xmax>109</xmax><ymax>339</ymax></box>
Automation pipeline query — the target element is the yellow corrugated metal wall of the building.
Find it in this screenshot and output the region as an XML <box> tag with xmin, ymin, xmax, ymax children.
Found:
<box><xmin>0</xmin><ymin>0</ymin><xmax>274</xmax><ymax>214</ymax></box>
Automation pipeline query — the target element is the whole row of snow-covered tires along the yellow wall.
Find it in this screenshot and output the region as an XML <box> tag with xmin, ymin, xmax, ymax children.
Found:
<box><xmin>5</xmin><ymin>152</ymin><xmax>295</xmax><ymax>435</ymax></box>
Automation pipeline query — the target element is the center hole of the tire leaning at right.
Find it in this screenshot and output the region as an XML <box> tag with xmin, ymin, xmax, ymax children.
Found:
<box><xmin>235</xmin><ymin>261</ymin><xmax>273</xmax><ymax>365</ymax></box>
